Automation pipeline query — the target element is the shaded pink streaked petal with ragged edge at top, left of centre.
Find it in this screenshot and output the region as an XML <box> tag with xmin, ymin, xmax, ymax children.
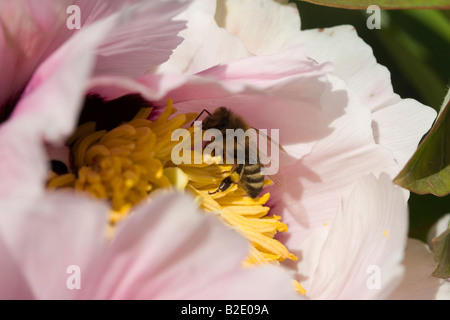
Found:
<box><xmin>95</xmin><ymin>0</ymin><xmax>191</xmax><ymax>77</ymax></box>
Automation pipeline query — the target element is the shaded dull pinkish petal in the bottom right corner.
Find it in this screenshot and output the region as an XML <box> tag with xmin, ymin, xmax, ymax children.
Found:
<box><xmin>389</xmin><ymin>239</ymin><xmax>450</xmax><ymax>300</ymax></box>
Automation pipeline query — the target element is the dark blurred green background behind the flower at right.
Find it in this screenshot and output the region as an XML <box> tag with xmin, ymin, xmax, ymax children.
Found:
<box><xmin>290</xmin><ymin>0</ymin><xmax>450</xmax><ymax>241</ymax></box>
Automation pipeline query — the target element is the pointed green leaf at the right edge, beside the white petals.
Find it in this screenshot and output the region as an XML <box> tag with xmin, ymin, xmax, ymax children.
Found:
<box><xmin>394</xmin><ymin>95</ymin><xmax>450</xmax><ymax>196</ymax></box>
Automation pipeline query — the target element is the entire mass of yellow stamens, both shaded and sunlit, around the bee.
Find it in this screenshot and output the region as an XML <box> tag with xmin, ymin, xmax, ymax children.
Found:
<box><xmin>47</xmin><ymin>95</ymin><xmax>297</xmax><ymax>267</ymax></box>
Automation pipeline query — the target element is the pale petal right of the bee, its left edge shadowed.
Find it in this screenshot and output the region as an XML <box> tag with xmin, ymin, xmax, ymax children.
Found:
<box><xmin>271</xmin><ymin>76</ymin><xmax>398</xmax><ymax>247</ymax></box>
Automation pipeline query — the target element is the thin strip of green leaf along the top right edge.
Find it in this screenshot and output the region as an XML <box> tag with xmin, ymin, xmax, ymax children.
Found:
<box><xmin>303</xmin><ymin>0</ymin><xmax>450</xmax><ymax>9</ymax></box>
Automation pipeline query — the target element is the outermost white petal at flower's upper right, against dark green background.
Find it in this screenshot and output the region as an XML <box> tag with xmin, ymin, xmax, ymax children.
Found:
<box><xmin>294</xmin><ymin>26</ymin><xmax>436</xmax><ymax>161</ymax></box>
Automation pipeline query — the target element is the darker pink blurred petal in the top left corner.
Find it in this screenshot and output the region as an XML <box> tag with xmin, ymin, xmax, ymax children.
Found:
<box><xmin>0</xmin><ymin>0</ymin><xmax>67</xmax><ymax>116</ymax></box>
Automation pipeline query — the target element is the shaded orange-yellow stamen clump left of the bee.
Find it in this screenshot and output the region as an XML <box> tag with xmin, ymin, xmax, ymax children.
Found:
<box><xmin>48</xmin><ymin>97</ymin><xmax>191</xmax><ymax>223</ymax></box>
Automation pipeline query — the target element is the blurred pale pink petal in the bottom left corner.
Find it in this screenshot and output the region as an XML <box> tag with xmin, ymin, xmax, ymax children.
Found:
<box><xmin>0</xmin><ymin>192</ymin><xmax>107</xmax><ymax>299</ymax></box>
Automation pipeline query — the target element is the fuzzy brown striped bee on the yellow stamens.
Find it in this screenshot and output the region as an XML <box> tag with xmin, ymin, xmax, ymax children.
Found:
<box><xmin>197</xmin><ymin>107</ymin><xmax>282</xmax><ymax>198</ymax></box>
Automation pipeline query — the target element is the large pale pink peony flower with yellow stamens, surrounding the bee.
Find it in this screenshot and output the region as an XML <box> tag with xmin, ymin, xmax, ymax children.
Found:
<box><xmin>0</xmin><ymin>0</ymin><xmax>442</xmax><ymax>299</ymax></box>
